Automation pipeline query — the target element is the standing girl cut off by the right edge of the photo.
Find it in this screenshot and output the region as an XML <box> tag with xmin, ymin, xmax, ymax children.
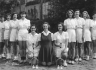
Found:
<box><xmin>91</xmin><ymin>13</ymin><xmax>96</xmax><ymax>59</ymax></box>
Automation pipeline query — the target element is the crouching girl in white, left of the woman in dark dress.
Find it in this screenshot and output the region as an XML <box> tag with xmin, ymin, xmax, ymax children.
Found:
<box><xmin>26</xmin><ymin>25</ymin><xmax>40</xmax><ymax>68</ymax></box>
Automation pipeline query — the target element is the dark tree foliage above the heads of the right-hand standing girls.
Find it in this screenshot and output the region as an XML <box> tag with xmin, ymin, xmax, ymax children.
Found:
<box><xmin>49</xmin><ymin>0</ymin><xmax>96</xmax><ymax>21</ymax></box>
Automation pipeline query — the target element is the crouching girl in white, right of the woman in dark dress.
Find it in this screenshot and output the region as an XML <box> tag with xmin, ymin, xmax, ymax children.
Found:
<box><xmin>53</xmin><ymin>23</ymin><xmax>69</xmax><ymax>66</ymax></box>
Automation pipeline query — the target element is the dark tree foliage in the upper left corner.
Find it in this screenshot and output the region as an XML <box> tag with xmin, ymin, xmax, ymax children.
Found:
<box><xmin>0</xmin><ymin>0</ymin><xmax>19</xmax><ymax>14</ymax></box>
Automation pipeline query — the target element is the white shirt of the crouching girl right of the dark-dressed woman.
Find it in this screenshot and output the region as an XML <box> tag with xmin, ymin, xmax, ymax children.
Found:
<box><xmin>53</xmin><ymin>31</ymin><xmax>69</xmax><ymax>44</ymax></box>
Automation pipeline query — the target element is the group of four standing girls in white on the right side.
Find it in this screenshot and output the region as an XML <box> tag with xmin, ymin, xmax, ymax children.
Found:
<box><xmin>64</xmin><ymin>10</ymin><xmax>96</xmax><ymax>64</ymax></box>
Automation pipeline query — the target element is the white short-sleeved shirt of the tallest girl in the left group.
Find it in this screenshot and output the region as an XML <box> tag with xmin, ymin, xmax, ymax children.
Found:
<box><xmin>18</xmin><ymin>19</ymin><xmax>30</xmax><ymax>33</ymax></box>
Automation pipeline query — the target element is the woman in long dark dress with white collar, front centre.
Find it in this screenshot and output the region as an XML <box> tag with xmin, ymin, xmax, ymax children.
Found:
<box><xmin>39</xmin><ymin>22</ymin><xmax>55</xmax><ymax>66</ymax></box>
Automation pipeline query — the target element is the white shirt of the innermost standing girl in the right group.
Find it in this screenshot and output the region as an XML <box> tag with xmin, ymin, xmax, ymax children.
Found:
<box><xmin>64</xmin><ymin>19</ymin><xmax>77</xmax><ymax>29</ymax></box>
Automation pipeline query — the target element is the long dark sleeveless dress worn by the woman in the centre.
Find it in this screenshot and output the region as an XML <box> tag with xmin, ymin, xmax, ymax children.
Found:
<box><xmin>39</xmin><ymin>33</ymin><xmax>55</xmax><ymax>64</ymax></box>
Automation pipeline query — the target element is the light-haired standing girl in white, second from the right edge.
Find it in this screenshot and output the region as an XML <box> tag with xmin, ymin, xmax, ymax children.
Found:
<box><xmin>83</xmin><ymin>11</ymin><xmax>92</xmax><ymax>60</ymax></box>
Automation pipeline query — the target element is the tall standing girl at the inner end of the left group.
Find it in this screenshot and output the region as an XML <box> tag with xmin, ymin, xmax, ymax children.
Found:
<box><xmin>18</xmin><ymin>11</ymin><xmax>30</xmax><ymax>63</ymax></box>
